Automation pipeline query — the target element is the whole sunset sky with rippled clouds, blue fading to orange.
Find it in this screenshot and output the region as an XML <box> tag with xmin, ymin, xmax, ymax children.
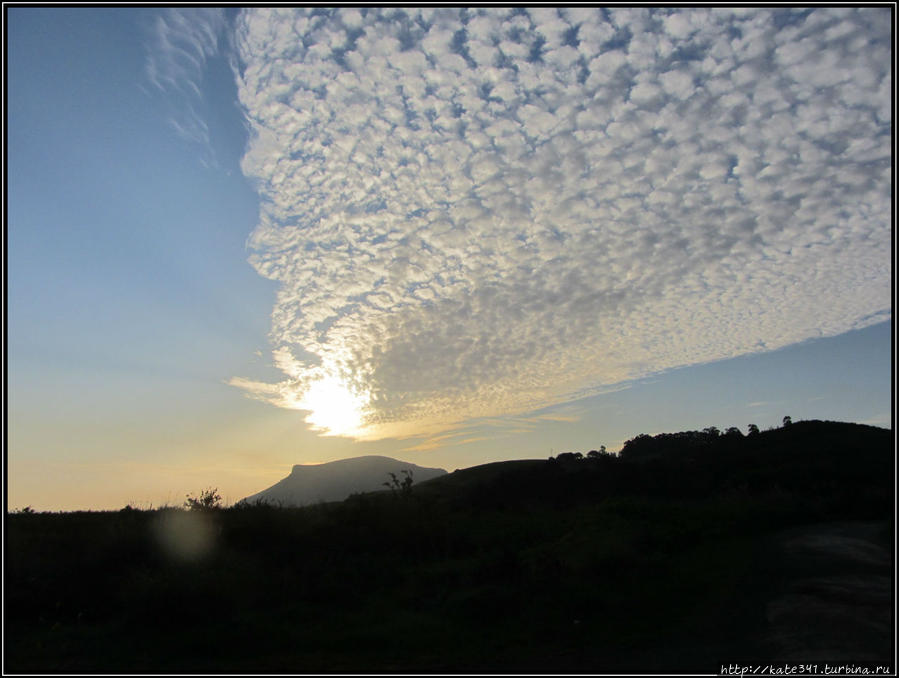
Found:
<box><xmin>4</xmin><ymin>6</ymin><xmax>894</xmax><ymax>510</ymax></box>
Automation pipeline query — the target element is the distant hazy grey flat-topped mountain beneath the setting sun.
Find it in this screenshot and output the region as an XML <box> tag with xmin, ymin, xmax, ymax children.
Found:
<box><xmin>242</xmin><ymin>455</ymin><xmax>446</xmax><ymax>506</ymax></box>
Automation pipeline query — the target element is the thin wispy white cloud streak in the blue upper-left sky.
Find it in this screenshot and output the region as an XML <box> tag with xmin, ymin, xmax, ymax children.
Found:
<box><xmin>145</xmin><ymin>8</ymin><xmax>227</xmax><ymax>164</ymax></box>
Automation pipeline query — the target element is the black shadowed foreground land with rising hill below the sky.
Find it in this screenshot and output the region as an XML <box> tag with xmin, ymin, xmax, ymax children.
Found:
<box><xmin>4</xmin><ymin>422</ymin><xmax>895</xmax><ymax>674</ymax></box>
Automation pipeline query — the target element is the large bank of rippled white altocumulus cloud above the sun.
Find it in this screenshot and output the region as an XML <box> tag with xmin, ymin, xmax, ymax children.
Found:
<box><xmin>231</xmin><ymin>8</ymin><xmax>892</xmax><ymax>438</ymax></box>
